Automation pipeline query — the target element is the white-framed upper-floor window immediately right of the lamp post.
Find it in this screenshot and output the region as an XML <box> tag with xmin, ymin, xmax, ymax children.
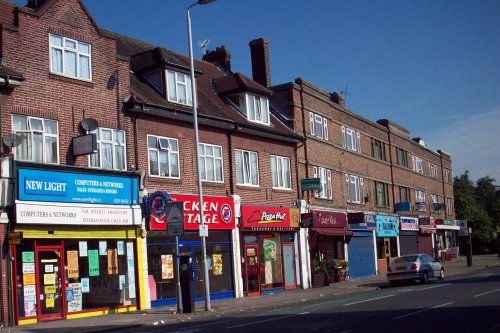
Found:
<box><xmin>198</xmin><ymin>143</ymin><xmax>224</xmax><ymax>183</ymax></box>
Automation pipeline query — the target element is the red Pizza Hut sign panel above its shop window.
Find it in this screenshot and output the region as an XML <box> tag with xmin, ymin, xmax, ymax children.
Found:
<box><xmin>241</xmin><ymin>206</ymin><xmax>294</xmax><ymax>231</ymax></box>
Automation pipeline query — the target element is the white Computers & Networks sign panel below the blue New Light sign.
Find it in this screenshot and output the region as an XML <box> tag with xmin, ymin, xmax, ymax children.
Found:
<box><xmin>16</xmin><ymin>201</ymin><xmax>141</xmax><ymax>226</ymax></box>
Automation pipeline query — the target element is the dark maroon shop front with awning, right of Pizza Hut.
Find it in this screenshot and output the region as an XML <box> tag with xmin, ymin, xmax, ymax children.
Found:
<box><xmin>309</xmin><ymin>210</ymin><xmax>353</xmax><ymax>283</ymax></box>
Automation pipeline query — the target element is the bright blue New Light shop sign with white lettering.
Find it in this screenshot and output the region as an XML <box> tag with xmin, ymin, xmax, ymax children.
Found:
<box><xmin>18</xmin><ymin>169</ymin><xmax>139</xmax><ymax>205</ymax></box>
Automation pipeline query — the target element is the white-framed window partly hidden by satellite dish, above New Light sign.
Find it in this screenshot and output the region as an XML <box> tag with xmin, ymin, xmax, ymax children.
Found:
<box><xmin>89</xmin><ymin>127</ymin><xmax>127</xmax><ymax>171</ymax></box>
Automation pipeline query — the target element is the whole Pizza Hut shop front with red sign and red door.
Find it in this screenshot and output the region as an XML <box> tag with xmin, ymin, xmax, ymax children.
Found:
<box><xmin>240</xmin><ymin>206</ymin><xmax>300</xmax><ymax>296</ymax></box>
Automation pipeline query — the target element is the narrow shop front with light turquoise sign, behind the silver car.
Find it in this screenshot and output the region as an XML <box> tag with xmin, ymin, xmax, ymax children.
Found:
<box><xmin>375</xmin><ymin>215</ymin><xmax>399</xmax><ymax>274</ymax></box>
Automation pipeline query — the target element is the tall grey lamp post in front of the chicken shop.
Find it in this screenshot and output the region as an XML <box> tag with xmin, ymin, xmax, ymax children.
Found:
<box><xmin>187</xmin><ymin>0</ymin><xmax>215</xmax><ymax>311</ymax></box>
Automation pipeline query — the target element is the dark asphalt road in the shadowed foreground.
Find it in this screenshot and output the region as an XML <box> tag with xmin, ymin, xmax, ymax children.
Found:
<box><xmin>116</xmin><ymin>267</ymin><xmax>500</xmax><ymax>333</ymax></box>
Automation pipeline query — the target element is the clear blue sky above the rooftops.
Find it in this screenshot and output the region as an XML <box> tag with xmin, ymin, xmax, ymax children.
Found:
<box><xmin>12</xmin><ymin>0</ymin><xmax>500</xmax><ymax>185</ymax></box>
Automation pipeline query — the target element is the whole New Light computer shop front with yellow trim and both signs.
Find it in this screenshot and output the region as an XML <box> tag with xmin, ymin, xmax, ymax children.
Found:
<box><xmin>11</xmin><ymin>164</ymin><xmax>142</xmax><ymax>325</ymax></box>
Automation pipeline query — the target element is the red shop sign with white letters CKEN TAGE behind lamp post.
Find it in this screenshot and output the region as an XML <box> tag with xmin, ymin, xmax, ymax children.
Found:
<box><xmin>170</xmin><ymin>194</ymin><xmax>235</xmax><ymax>230</ymax></box>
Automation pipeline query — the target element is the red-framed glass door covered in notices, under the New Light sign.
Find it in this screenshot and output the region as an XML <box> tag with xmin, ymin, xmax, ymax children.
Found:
<box><xmin>35</xmin><ymin>246</ymin><xmax>65</xmax><ymax>321</ymax></box>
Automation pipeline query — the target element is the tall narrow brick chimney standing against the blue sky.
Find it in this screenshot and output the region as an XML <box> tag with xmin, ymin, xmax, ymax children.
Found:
<box><xmin>249</xmin><ymin>38</ymin><xmax>271</xmax><ymax>87</ymax></box>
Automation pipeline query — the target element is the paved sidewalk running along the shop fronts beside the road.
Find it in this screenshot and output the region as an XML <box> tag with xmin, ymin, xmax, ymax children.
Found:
<box><xmin>5</xmin><ymin>254</ymin><xmax>500</xmax><ymax>333</ymax></box>
